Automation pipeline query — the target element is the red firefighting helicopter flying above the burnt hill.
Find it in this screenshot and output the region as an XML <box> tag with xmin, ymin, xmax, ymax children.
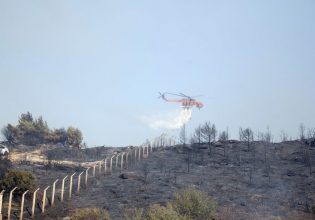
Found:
<box><xmin>159</xmin><ymin>92</ymin><xmax>203</xmax><ymax>110</ymax></box>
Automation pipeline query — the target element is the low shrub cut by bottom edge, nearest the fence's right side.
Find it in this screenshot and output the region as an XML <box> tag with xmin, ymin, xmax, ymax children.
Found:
<box><xmin>70</xmin><ymin>208</ymin><xmax>111</xmax><ymax>220</ymax></box>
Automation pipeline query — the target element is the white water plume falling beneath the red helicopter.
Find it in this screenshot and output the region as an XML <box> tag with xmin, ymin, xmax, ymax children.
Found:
<box><xmin>142</xmin><ymin>109</ymin><xmax>192</xmax><ymax>129</ymax></box>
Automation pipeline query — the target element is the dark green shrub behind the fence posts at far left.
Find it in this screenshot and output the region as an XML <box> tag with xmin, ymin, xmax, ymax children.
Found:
<box><xmin>0</xmin><ymin>169</ymin><xmax>35</xmax><ymax>195</ymax></box>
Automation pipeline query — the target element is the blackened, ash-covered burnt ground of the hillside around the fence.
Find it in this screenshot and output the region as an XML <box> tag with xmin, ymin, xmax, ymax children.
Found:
<box><xmin>4</xmin><ymin>142</ymin><xmax>315</xmax><ymax>219</ymax></box>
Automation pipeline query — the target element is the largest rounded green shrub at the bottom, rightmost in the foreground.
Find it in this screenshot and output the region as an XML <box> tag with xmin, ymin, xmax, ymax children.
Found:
<box><xmin>170</xmin><ymin>189</ymin><xmax>217</xmax><ymax>220</ymax></box>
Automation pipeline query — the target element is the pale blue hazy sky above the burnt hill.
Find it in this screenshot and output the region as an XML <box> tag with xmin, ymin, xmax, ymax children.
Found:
<box><xmin>0</xmin><ymin>0</ymin><xmax>315</xmax><ymax>146</ymax></box>
